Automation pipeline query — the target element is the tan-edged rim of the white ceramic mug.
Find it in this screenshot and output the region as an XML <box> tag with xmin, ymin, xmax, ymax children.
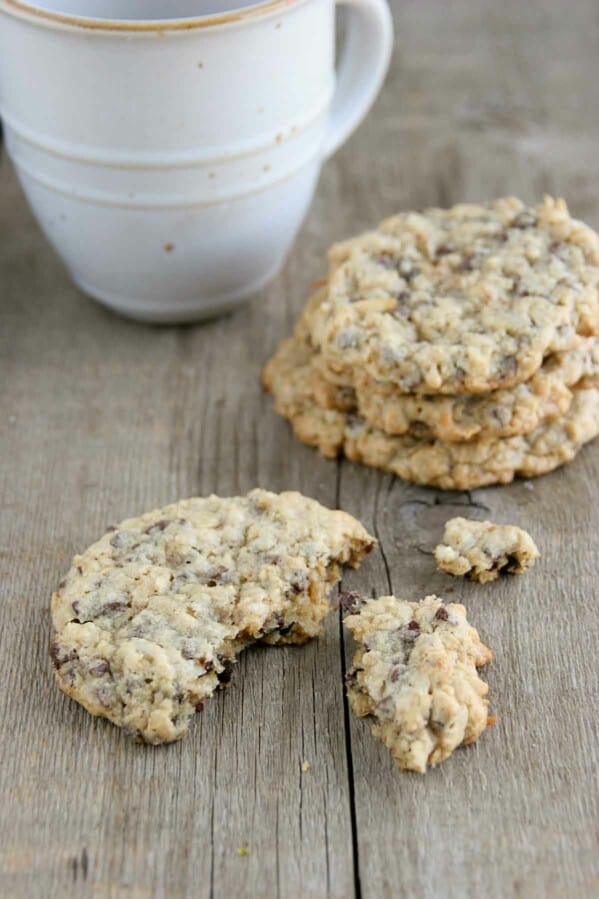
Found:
<box><xmin>0</xmin><ymin>0</ymin><xmax>304</xmax><ymax>33</ymax></box>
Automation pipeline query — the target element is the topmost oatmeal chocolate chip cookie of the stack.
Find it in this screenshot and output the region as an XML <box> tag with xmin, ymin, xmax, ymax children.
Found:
<box><xmin>308</xmin><ymin>198</ymin><xmax>599</xmax><ymax>395</ymax></box>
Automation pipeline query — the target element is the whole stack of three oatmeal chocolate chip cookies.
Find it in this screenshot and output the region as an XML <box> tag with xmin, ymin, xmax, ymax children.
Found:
<box><xmin>263</xmin><ymin>198</ymin><xmax>599</xmax><ymax>489</ymax></box>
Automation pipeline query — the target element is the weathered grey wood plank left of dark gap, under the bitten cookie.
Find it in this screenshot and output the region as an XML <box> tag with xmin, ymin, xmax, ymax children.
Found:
<box><xmin>0</xmin><ymin>149</ymin><xmax>353</xmax><ymax>897</ymax></box>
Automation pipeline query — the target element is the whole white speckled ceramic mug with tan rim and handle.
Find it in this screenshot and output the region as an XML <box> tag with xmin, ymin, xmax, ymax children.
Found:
<box><xmin>0</xmin><ymin>0</ymin><xmax>392</xmax><ymax>322</ymax></box>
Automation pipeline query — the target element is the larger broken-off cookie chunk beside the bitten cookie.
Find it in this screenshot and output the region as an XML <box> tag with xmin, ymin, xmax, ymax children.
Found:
<box><xmin>344</xmin><ymin>596</ymin><xmax>493</xmax><ymax>773</ymax></box>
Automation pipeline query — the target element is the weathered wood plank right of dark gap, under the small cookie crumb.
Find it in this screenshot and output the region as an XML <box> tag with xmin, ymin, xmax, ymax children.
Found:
<box><xmin>339</xmin><ymin>2</ymin><xmax>599</xmax><ymax>899</ymax></box>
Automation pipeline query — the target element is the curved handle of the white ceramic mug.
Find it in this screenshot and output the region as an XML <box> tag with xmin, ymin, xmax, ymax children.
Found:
<box><xmin>323</xmin><ymin>0</ymin><xmax>393</xmax><ymax>159</ymax></box>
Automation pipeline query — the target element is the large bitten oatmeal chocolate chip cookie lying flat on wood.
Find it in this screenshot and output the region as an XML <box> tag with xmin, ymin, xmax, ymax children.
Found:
<box><xmin>51</xmin><ymin>490</ymin><xmax>375</xmax><ymax>743</ymax></box>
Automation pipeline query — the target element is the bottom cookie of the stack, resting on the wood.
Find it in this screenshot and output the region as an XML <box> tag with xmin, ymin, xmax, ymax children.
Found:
<box><xmin>263</xmin><ymin>338</ymin><xmax>599</xmax><ymax>490</ymax></box>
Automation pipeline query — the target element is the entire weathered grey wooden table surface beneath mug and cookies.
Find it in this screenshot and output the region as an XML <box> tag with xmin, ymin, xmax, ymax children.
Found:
<box><xmin>0</xmin><ymin>0</ymin><xmax>599</xmax><ymax>899</ymax></box>
